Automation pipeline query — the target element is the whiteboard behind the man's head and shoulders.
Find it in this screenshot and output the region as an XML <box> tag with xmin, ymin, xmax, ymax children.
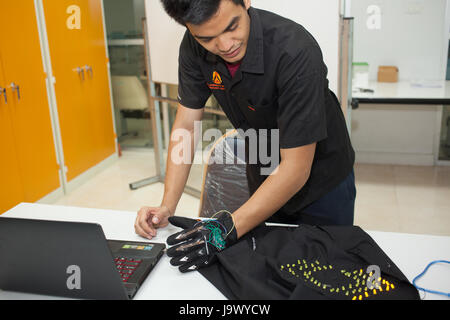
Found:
<box><xmin>146</xmin><ymin>0</ymin><xmax>340</xmax><ymax>93</ymax></box>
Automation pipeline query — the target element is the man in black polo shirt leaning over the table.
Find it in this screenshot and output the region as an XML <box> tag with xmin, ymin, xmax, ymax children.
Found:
<box><xmin>135</xmin><ymin>0</ymin><xmax>356</xmax><ymax>258</ymax></box>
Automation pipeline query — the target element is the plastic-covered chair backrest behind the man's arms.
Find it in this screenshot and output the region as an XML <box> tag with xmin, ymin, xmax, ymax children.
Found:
<box><xmin>199</xmin><ymin>130</ymin><xmax>249</xmax><ymax>217</ymax></box>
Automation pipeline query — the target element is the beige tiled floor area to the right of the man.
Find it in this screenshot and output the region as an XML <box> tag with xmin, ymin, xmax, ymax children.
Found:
<box><xmin>355</xmin><ymin>164</ymin><xmax>450</xmax><ymax>235</ymax></box>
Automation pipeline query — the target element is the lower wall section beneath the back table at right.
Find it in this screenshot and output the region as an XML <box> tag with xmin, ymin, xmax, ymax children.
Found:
<box><xmin>352</xmin><ymin>104</ymin><xmax>440</xmax><ymax>165</ymax></box>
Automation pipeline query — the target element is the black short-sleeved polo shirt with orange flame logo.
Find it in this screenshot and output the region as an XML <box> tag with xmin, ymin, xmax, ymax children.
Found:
<box><xmin>178</xmin><ymin>8</ymin><xmax>354</xmax><ymax>220</ymax></box>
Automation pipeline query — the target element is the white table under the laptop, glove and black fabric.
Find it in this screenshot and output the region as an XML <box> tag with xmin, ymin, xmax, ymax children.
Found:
<box><xmin>0</xmin><ymin>203</ymin><xmax>450</xmax><ymax>300</ymax></box>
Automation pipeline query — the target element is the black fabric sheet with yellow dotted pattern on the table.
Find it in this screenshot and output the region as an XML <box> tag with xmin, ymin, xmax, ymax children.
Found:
<box><xmin>199</xmin><ymin>225</ymin><xmax>419</xmax><ymax>300</ymax></box>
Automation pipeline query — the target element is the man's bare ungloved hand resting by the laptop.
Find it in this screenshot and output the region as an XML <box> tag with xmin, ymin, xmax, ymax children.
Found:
<box><xmin>134</xmin><ymin>206</ymin><xmax>171</xmax><ymax>240</ymax></box>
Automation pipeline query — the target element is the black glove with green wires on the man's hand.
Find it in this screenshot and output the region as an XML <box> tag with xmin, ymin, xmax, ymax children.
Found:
<box><xmin>167</xmin><ymin>211</ymin><xmax>237</xmax><ymax>273</ymax></box>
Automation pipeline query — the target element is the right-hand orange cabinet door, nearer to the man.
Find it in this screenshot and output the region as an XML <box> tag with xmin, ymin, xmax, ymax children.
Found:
<box><xmin>43</xmin><ymin>0</ymin><xmax>116</xmax><ymax>181</ymax></box>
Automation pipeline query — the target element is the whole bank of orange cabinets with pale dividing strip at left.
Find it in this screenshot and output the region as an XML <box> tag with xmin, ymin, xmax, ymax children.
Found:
<box><xmin>0</xmin><ymin>0</ymin><xmax>116</xmax><ymax>214</ymax></box>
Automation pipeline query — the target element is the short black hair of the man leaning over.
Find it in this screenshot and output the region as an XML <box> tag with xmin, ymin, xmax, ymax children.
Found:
<box><xmin>161</xmin><ymin>0</ymin><xmax>245</xmax><ymax>26</ymax></box>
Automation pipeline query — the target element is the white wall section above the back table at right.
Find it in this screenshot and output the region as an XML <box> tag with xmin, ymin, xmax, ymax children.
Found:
<box><xmin>351</xmin><ymin>0</ymin><xmax>448</xmax><ymax>80</ymax></box>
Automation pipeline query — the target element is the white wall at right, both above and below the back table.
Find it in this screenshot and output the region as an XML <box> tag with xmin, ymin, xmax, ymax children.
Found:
<box><xmin>351</xmin><ymin>0</ymin><xmax>449</xmax><ymax>165</ymax></box>
